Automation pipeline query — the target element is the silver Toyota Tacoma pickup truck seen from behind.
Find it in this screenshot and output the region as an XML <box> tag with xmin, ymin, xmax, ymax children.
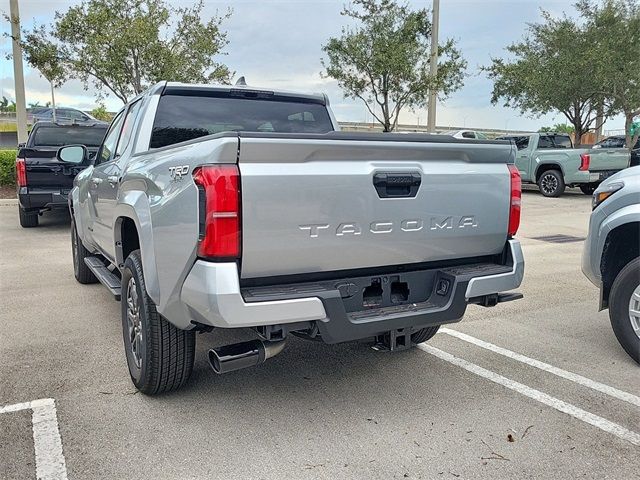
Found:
<box><xmin>58</xmin><ymin>82</ymin><xmax>524</xmax><ymax>394</ymax></box>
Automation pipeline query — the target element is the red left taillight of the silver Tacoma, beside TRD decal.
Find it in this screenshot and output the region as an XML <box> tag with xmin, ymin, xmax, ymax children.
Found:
<box><xmin>193</xmin><ymin>165</ymin><xmax>240</xmax><ymax>260</ymax></box>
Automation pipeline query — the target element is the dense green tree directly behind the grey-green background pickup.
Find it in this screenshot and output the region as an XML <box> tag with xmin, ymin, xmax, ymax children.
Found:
<box><xmin>483</xmin><ymin>11</ymin><xmax>610</xmax><ymax>145</ymax></box>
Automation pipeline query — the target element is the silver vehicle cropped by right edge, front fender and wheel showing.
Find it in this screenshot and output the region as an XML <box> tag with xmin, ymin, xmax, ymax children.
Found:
<box><xmin>582</xmin><ymin>167</ymin><xmax>640</xmax><ymax>363</ymax></box>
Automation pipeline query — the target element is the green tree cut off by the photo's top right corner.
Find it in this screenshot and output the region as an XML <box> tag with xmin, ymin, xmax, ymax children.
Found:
<box><xmin>576</xmin><ymin>0</ymin><xmax>640</xmax><ymax>149</ymax></box>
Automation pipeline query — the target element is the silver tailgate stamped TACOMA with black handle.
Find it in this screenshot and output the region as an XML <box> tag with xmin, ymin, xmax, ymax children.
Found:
<box><xmin>239</xmin><ymin>134</ymin><xmax>515</xmax><ymax>278</ymax></box>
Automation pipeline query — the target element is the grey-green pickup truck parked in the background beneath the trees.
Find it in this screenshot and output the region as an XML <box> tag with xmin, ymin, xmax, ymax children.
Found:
<box><xmin>497</xmin><ymin>133</ymin><xmax>630</xmax><ymax>197</ymax></box>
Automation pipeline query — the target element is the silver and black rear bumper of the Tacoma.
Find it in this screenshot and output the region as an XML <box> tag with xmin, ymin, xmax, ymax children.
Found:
<box><xmin>181</xmin><ymin>240</ymin><xmax>524</xmax><ymax>343</ymax></box>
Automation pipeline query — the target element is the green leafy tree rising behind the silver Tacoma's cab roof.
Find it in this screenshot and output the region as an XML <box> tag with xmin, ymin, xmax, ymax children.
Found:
<box><xmin>28</xmin><ymin>0</ymin><xmax>231</xmax><ymax>103</ymax></box>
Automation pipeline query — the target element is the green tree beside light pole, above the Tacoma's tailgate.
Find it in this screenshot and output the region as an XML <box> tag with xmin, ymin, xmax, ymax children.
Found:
<box><xmin>322</xmin><ymin>0</ymin><xmax>467</xmax><ymax>132</ymax></box>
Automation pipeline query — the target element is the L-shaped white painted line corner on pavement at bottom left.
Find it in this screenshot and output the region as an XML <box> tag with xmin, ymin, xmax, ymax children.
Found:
<box><xmin>0</xmin><ymin>398</ymin><xmax>67</xmax><ymax>480</ymax></box>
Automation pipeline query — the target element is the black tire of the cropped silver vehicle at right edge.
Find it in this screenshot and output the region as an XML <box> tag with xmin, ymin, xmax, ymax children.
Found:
<box><xmin>609</xmin><ymin>258</ymin><xmax>640</xmax><ymax>363</ymax></box>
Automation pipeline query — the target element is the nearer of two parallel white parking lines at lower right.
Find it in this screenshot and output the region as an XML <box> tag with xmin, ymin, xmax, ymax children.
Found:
<box><xmin>418</xmin><ymin>343</ymin><xmax>640</xmax><ymax>446</ymax></box>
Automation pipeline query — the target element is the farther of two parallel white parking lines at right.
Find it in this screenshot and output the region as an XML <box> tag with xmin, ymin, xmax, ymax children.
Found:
<box><xmin>440</xmin><ymin>328</ymin><xmax>640</xmax><ymax>407</ymax></box>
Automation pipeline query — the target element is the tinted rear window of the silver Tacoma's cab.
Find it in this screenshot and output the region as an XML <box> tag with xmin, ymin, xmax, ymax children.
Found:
<box><xmin>150</xmin><ymin>95</ymin><xmax>333</xmax><ymax>148</ymax></box>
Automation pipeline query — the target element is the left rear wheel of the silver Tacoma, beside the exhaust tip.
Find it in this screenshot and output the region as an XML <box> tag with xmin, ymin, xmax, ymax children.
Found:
<box><xmin>121</xmin><ymin>250</ymin><xmax>196</xmax><ymax>395</ymax></box>
